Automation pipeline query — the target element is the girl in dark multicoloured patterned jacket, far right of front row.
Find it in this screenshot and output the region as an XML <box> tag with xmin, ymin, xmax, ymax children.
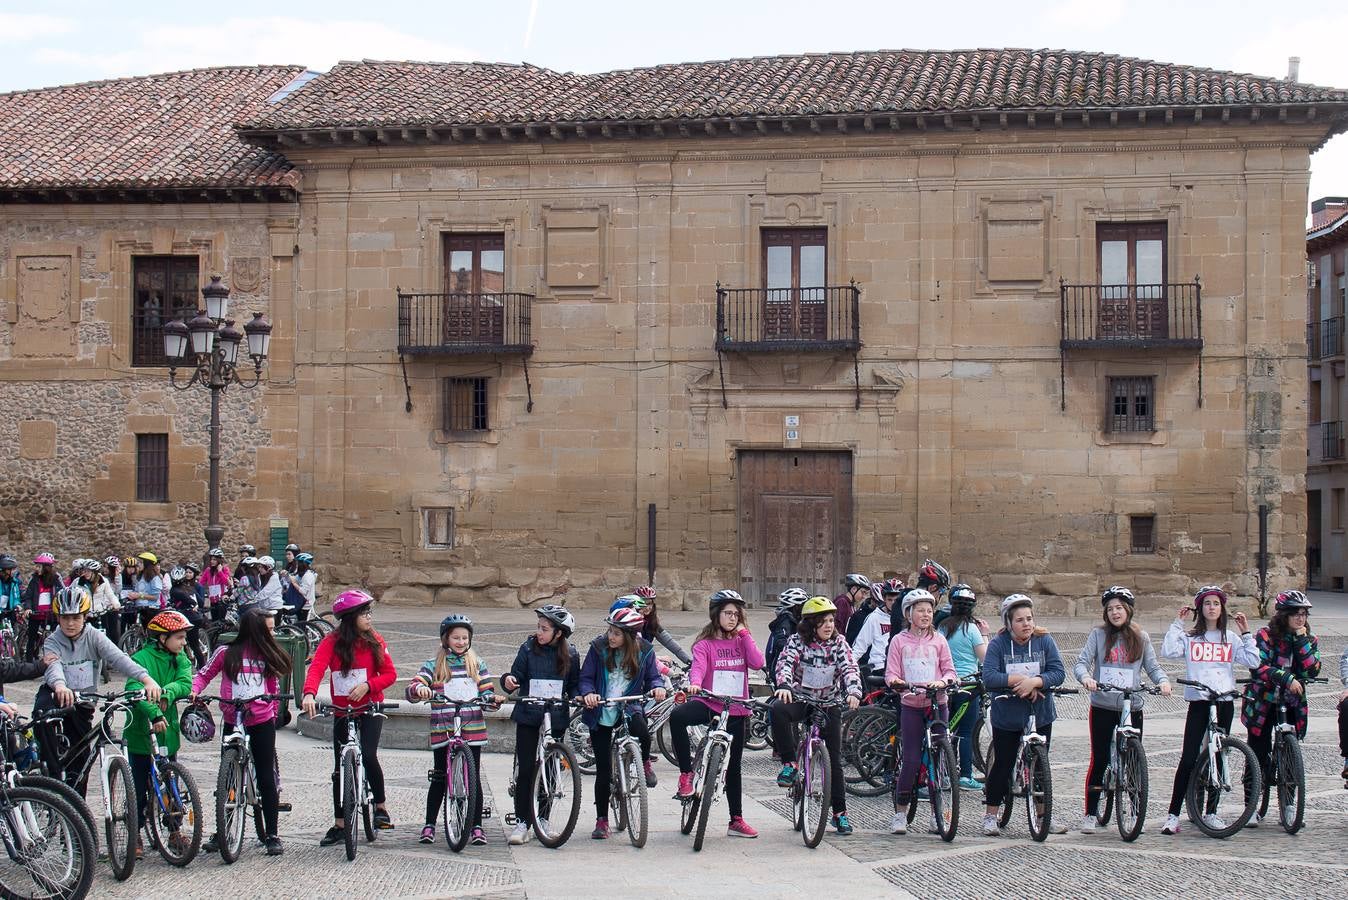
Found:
<box><xmin>1240</xmin><ymin>590</ymin><xmax>1320</xmax><ymax>829</ymax></box>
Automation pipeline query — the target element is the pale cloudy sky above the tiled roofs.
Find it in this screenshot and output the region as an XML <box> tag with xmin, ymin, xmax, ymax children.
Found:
<box><xmin>0</xmin><ymin>0</ymin><xmax>1348</xmax><ymax>212</ymax></box>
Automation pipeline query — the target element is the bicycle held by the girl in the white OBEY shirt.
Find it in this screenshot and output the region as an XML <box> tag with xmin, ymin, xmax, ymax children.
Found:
<box><xmin>1175</xmin><ymin>678</ymin><xmax>1263</xmax><ymax>838</ymax></box>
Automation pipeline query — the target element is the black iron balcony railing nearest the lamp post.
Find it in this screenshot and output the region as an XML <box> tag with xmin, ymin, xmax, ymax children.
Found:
<box><xmin>398</xmin><ymin>291</ymin><xmax>534</xmax><ymax>356</ymax></box>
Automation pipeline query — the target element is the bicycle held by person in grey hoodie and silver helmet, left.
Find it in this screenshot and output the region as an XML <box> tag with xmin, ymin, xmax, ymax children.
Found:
<box><xmin>34</xmin><ymin>690</ymin><xmax>146</xmax><ymax>881</ymax></box>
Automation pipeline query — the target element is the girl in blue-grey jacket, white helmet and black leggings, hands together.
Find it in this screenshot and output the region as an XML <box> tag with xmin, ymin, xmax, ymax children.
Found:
<box><xmin>983</xmin><ymin>594</ymin><xmax>1068</xmax><ymax>838</ymax></box>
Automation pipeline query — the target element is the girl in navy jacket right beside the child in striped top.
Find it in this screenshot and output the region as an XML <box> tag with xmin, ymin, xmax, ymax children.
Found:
<box><xmin>501</xmin><ymin>604</ymin><xmax>581</xmax><ymax>846</ymax></box>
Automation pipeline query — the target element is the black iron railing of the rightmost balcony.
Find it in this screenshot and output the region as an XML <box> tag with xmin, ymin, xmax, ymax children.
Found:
<box><xmin>1058</xmin><ymin>279</ymin><xmax>1202</xmax><ymax>350</ymax></box>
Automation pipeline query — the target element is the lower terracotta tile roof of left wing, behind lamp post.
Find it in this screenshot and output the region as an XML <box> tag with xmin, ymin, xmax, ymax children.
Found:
<box><xmin>0</xmin><ymin>66</ymin><xmax>305</xmax><ymax>190</ymax></box>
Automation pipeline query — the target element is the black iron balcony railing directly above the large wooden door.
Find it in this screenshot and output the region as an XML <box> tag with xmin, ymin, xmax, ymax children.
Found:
<box><xmin>716</xmin><ymin>284</ymin><xmax>861</xmax><ymax>352</ymax></box>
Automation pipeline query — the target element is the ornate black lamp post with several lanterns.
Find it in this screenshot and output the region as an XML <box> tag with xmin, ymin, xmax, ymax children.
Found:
<box><xmin>164</xmin><ymin>275</ymin><xmax>271</xmax><ymax>548</ymax></box>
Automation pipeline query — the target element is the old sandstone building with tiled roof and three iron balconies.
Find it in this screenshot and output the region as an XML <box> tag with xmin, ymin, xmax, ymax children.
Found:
<box><xmin>0</xmin><ymin>50</ymin><xmax>1348</xmax><ymax>610</ymax></box>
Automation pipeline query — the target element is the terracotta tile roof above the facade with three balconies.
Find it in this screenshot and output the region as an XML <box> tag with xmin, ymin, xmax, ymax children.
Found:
<box><xmin>240</xmin><ymin>50</ymin><xmax>1348</xmax><ymax>132</ymax></box>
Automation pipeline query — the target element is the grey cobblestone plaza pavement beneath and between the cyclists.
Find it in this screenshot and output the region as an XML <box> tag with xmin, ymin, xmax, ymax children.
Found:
<box><xmin>9</xmin><ymin>610</ymin><xmax>1348</xmax><ymax>900</ymax></box>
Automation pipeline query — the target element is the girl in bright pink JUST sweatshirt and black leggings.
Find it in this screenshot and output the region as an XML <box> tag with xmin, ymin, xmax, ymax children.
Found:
<box><xmin>670</xmin><ymin>590</ymin><xmax>764</xmax><ymax>838</ymax></box>
